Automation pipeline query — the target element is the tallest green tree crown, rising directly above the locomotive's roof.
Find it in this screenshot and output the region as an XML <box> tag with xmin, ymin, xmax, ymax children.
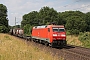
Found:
<box><xmin>39</xmin><ymin>6</ymin><xmax>58</xmax><ymax>25</ymax></box>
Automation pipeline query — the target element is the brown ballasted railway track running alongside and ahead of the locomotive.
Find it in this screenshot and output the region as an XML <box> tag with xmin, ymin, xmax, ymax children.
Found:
<box><xmin>12</xmin><ymin>36</ymin><xmax>90</xmax><ymax>60</ymax></box>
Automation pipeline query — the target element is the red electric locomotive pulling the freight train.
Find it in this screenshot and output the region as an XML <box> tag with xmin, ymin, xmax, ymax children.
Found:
<box><xmin>32</xmin><ymin>25</ymin><xmax>67</xmax><ymax>47</ymax></box>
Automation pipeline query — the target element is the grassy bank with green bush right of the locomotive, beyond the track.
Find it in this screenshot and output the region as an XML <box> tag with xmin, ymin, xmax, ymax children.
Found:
<box><xmin>67</xmin><ymin>32</ymin><xmax>90</xmax><ymax>48</ymax></box>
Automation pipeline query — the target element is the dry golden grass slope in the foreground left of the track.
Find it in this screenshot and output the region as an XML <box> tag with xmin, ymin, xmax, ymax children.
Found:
<box><xmin>0</xmin><ymin>33</ymin><xmax>63</xmax><ymax>60</ymax></box>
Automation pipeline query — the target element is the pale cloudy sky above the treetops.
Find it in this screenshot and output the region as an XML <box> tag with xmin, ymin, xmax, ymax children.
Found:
<box><xmin>0</xmin><ymin>0</ymin><xmax>90</xmax><ymax>26</ymax></box>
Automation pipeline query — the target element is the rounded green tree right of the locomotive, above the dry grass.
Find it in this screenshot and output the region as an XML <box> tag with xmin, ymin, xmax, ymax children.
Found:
<box><xmin>65</xmin><ymin>16</ymin><xmax>87</xmax><ymax>34</ymax></box>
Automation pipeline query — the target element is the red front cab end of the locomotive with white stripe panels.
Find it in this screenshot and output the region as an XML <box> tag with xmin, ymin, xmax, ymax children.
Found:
<box><xmin>51</xmin><ymin>26</ymin><xmax>66</xmax><ymax>47</ymax></box>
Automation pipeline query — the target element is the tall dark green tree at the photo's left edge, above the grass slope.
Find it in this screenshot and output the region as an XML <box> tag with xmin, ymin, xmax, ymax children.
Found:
<box><xmin>0</xmin><ymin>4</ymin><xmax>8</xmax><ymax>32</ymax></box>
